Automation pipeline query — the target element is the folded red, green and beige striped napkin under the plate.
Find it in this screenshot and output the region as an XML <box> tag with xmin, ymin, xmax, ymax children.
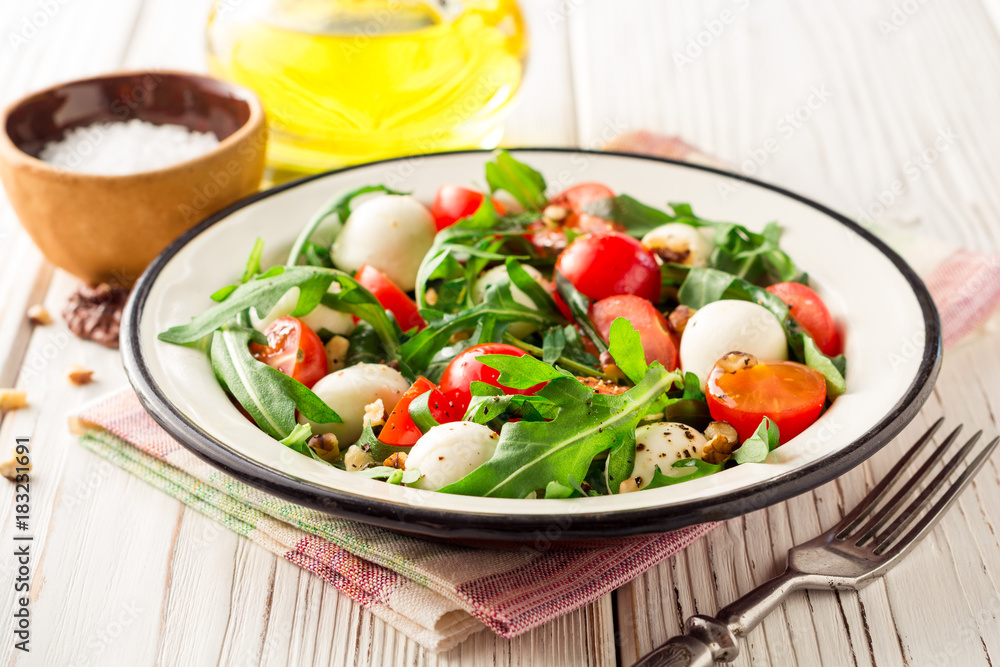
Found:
<box><xmin>71</xmin><ymin>132</ymin><xmax>1000</xmax><ymax>650</ymax></box>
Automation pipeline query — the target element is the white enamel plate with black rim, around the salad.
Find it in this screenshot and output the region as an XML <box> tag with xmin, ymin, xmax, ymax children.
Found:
<box><xmin>122</xmin><ymin>149</ymin><xmax>940</xmax><ymax>541</ymax></box>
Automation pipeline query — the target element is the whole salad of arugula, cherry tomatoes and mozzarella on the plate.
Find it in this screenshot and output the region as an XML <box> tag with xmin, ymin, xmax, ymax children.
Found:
<box><xmin>159</xmin><ymin>151</ymin><xmax>846</xmax><ymax>498</ymax></box>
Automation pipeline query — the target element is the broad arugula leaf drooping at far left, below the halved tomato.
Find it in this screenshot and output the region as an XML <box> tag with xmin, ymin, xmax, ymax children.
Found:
<box><xmin>211</xmin><ymin>326</ymin><xmax>341</xmax><ymax>440</ymax></box>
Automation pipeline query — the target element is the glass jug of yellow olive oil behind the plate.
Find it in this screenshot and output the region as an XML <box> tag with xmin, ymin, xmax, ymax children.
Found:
<box><xmin>208</xmin><ymin>0</ymin><xmax>527</xmax><ymax>173</ymax></box>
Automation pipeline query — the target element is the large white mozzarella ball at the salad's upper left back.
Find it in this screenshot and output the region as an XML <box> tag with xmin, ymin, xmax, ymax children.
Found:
<box><xmin>330</xmin><ymin>195</ymin><xmax>437</xmax><ymax>292</ymax></box>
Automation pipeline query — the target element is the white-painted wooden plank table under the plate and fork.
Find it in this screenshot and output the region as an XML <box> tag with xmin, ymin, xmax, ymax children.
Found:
<box><xmin>0</xmin><ymin>0</ymin><xmax>1000</xmax><ymax>666</ymax></box>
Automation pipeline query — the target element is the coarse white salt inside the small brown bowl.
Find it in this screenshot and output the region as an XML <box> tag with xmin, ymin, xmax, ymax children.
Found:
<box><xmin>39</xmin><ymin>119</ymin><xmax>219</xmax><ymax>176</ymax></box>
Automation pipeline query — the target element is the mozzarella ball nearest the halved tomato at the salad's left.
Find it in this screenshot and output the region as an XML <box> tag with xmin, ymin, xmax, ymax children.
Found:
<box><xmin>299</xmin><ymin>364</ymin><xmax>410</xmax><ymax>449</ymax></box>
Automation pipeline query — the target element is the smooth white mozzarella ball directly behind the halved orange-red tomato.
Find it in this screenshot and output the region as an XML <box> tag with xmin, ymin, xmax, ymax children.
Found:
<box><xmin>680</xmin><ymin>300</ymin><xmax>788</xmax><ymax>390</ymax></box>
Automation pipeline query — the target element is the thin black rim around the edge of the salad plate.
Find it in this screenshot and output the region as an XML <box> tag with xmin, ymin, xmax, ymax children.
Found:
<box><xmin>121</xmin><ymin>147</ymin><xmax>941</xmax><ymax>544</ymax></box>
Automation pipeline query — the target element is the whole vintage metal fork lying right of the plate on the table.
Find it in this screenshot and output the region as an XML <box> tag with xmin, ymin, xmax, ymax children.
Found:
<box><xmin>635</xmin><ymin>419</ymin><xmax>1000</xmax><ymax>667</ymax></box>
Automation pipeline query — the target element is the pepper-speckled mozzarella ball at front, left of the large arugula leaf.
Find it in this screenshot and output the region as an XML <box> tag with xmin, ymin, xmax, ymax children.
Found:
<box><xmin>406</xmin><ymin>422</ymin><xmax>500</xmax><ymax>491</ymax></box>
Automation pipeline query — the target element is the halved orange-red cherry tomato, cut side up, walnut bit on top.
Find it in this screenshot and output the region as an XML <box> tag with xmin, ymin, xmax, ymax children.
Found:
<box><xmin>705</xmin><ymin>361</ymin><xmax>826</xmax><ymax>444</ymax></box>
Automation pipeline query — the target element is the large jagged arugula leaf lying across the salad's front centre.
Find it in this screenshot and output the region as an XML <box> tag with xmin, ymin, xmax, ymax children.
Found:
<box><xmin>441</xmin><ymin>357</ymin><xmax>679</xmax><ymax>498</ymax></box>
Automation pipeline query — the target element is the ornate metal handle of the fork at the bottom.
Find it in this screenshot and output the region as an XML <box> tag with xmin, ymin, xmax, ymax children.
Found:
<box><xmin>633</xmin><ymin>570</ymin><xmax>809</xmax><ymax>667</ymax></box>
